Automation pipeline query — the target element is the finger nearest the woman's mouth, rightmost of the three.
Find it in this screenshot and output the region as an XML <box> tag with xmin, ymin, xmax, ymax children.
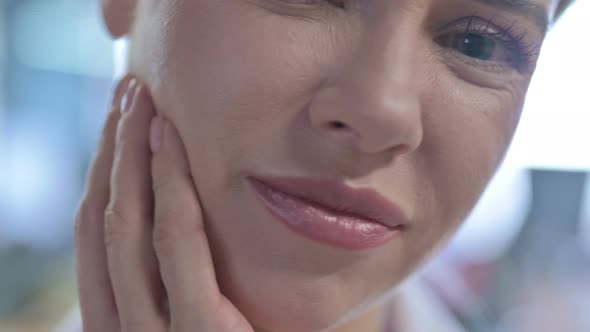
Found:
<box><xmin>150</xmin><ymin>117</ymin><xmax>221</xmax><ymax>330</ymax></box>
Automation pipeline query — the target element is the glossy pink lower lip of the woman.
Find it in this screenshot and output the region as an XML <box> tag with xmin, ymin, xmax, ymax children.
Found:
<box><xmin>250</xmin><ymin>179</ymin><xmax>400</xmax><ymax>250</ymax></box>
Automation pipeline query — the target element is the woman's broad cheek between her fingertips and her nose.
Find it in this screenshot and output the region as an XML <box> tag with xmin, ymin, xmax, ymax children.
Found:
<box><xmin>138</xmin><ymin>1</ymin><xmax>342</xmax><ymax>181</ymax></box>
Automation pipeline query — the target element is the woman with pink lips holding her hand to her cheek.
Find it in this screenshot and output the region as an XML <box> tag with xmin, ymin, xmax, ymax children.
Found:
<box><xmin>76</xmin><ymin>0</ymin><xmax>566</xmax><ymax>332</ymax></box>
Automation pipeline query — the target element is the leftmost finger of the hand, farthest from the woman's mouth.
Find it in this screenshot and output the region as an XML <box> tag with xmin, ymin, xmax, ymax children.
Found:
<box><xmin>74</xmin><ymin>76</ymin><xmax>130</xmax><ymax>332</ymax></box>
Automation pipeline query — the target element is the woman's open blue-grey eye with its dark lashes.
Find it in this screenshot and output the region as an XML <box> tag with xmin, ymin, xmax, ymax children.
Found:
<box><xmin>435</xmin><ymin>15</ymin><xmax>540</xmax><ymax>71</ymax></box>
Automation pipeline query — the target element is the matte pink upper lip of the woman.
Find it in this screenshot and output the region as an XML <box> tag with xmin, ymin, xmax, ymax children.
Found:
<box><xmin>250</xmin><ymin>176</ymin><xmax>409</xmax><ymax>228</ymax></box>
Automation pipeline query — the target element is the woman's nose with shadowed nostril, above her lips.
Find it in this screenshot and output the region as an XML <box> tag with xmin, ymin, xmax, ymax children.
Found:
<box><xmin>309</xmin><ymin>10</ymin><xmax>423</xmax><ymax>154</ymax></box>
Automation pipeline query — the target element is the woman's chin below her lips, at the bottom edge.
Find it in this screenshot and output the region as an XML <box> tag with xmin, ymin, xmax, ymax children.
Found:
<box><xmin>213</xmin><ymin>258</ymin><xmax>362</xmax><ymax>332</ymax></box>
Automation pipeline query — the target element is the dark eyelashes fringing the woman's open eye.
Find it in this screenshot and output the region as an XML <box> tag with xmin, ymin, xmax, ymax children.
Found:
<box><xmin>435</xmin><ymin>15</ymin><xmax>540</xmax><ymax>70</ymax></box>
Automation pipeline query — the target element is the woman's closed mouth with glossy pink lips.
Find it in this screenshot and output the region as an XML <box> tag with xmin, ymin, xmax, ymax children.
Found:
<box><xmin>248</xmin><ymin>177</ymin><xmax>409</xmax><ymax>250</ymax></box>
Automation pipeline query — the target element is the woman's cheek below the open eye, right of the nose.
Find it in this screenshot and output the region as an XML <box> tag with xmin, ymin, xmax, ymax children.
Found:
<box><xmin>418</xmin><ymin>77</ymin><xmax>524</xmax><ymax>243</ymax></box>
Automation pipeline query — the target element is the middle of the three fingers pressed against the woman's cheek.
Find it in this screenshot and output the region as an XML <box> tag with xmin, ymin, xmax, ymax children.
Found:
<box><xmin>105</xmin><ymin>83</ymin><xmax>166</xmax><ymax>332</ymax></box>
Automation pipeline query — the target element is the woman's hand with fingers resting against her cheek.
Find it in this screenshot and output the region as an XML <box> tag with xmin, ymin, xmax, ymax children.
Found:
<box><xmin>75</xmin><ymin>77</ymin><xmax>253</xmax><ymax>332</ymax></box>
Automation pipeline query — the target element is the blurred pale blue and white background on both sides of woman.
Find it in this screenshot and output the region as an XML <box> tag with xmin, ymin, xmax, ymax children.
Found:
<box><xmin>0</xmin><ymin>0</ymin><xmax>590</xmax><ymax>332</ymax></box>
